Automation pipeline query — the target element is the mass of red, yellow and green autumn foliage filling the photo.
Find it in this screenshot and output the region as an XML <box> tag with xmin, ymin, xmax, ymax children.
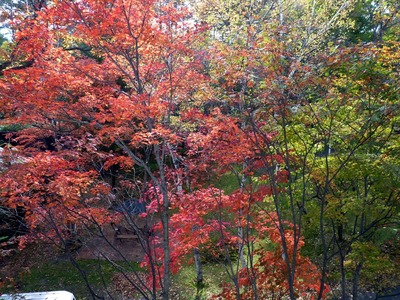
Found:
<box><xmin>0</xmin><ymin>0</ymin><xmax>400</xmax><ymax>299</ymax></box>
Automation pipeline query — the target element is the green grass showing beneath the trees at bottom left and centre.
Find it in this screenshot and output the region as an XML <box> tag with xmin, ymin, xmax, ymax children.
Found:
<box><xmin>18</xmin><ymin>260</ymin><xmax>230</xmax><ymax>300</ymax></box>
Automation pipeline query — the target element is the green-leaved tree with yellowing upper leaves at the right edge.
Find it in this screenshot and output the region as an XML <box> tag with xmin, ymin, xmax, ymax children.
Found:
<box><xmin>296</xmin><ymin>43</ymin><xmax>399</xmax><ymax>297</ymax></box>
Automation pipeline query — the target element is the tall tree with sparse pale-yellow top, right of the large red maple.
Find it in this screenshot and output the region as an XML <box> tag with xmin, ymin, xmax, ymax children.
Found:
<box><xmin>189</xmin><ymin>1</ymin><xmax>398</xmax><ymax>298</ymax></box>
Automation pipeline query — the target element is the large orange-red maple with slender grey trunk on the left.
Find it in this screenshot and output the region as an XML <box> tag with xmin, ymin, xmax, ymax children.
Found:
<box><xmin>1</xmin><ymin>1</ymin><xmax>211</xmax><ymax>299</ymax></box>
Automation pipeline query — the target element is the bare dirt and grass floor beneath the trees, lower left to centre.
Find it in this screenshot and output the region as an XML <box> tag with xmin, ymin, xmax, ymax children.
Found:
<box><xmin>0</xmin><ymin>228</ymin><xmax>229</xmax><ymax>300</ymax></box>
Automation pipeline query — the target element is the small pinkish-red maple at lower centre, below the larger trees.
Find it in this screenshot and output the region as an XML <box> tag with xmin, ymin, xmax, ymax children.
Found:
<box><xmin>164</xmin><ymin>110</ymin><xmax>328</xmax><ymax>299</ymax></box>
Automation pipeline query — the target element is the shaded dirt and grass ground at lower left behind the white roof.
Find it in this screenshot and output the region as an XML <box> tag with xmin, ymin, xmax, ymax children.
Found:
<box><xmin>0</xmin><ymin>225</ymin><xmax>144</xmax><ymax>299</ymax></box>
